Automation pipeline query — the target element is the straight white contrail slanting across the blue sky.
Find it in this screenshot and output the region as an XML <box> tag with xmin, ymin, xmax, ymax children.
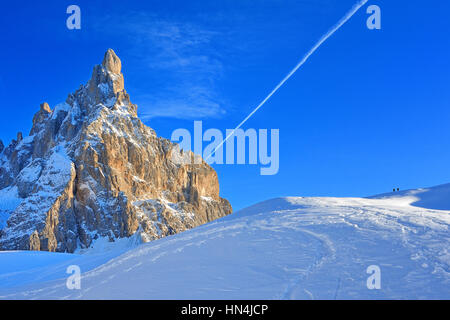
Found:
<box><xmin>205</xmin><ymin>0</ymin><xmax>368</xmax><ymax>161</ymax></box>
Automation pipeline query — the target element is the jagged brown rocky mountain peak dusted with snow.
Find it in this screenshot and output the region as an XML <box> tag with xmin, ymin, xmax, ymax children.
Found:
<box><xmin>0</xmin><ymin>49</ymin><xmax>232</xmax><ymax>252</ymax></box>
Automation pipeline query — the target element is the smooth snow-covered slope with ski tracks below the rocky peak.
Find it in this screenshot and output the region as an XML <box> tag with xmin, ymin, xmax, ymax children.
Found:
<box><xmin>0</xmin><ymin>185</ymin><xmax>450</xmax><ymax>299</ymax></box>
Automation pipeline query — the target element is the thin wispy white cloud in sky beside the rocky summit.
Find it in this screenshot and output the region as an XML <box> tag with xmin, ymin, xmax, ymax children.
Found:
<box><xmin>98</xmin><ymin>12</ymin><xmax>226</xmax><ymax>120</ymax></box>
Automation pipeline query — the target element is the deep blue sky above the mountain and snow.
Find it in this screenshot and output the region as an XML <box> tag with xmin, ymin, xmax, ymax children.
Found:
<box><xmin>0</xmin><ymin>0</ymin><xmax>450</xmax><ymax>209</ymax></box>
